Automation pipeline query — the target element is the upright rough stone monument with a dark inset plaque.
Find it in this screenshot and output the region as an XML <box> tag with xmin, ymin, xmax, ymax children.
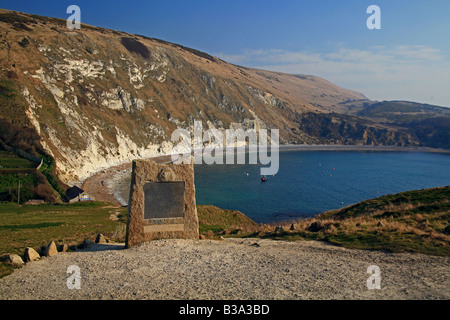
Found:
<box><xmin>126</xmin><ymin>160</ymin><xmax>199</xmax><ymax>248</ymax></box>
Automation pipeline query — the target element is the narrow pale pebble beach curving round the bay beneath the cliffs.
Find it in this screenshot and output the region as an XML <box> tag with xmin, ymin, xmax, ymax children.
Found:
<box><xmin>81</xmin><ymin>144</ymin><xmax>450</xmax><ymax>206</ymax></box>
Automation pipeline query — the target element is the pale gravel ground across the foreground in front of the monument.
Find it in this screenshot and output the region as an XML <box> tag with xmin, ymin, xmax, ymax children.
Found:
<box><xmin>0</xmin><ymin>239</ymin><xmax>450</xmax><ymax>300</ymax></box>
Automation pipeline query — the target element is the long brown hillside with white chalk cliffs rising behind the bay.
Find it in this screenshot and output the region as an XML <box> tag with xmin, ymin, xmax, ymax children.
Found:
<box><xmin>0</xmin><ymin>10</ymin><xmax>449</xmax><ymax>184</ymax></box>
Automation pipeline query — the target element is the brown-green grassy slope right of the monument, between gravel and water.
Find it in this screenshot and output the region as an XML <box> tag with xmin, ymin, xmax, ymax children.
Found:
<box><xmin>251</xmin><ymin>186</ymin><xmax>450</xmax><ymax>256</ymax></box>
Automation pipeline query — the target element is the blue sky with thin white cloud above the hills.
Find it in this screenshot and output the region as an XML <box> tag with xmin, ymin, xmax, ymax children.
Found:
<box><xmin>0</xmin><ymin>0</ymin><xmax>450</xmax><ymax>107</ymax></box>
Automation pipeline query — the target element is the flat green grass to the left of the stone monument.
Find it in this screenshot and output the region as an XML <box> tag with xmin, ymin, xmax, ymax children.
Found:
<box><xmin>0</xmin><ymin>202</ymin><xmax>127</xmax><ymax>277</ymax></box>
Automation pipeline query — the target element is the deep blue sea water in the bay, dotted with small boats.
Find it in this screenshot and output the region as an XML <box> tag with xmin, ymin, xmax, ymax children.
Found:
<box><xmin>195</xmin><ymin>151</ymin><xmax>450</xmax><ymax>222</ymax></box>
